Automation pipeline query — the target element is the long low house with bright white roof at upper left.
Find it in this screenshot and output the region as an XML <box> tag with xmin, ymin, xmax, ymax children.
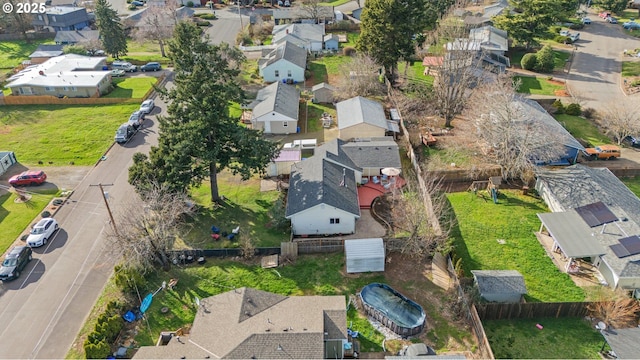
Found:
<box><xmin>5</xmin><ymin>54</ymin><xmax>111</xmax><ymax>98</ymax></box>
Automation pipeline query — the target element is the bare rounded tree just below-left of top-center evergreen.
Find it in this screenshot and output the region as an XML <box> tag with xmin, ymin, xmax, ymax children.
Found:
<box><xmin>336</xmin><ymin>54</ymin><xmax>385</xmax><ymax>99</ymax></box>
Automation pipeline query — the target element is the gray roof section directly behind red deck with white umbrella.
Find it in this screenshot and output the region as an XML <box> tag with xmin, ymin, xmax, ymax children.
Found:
<box><xmin>342</xmin><ymin>137</ymin><xmax>402</xmax><ymax>169</ymax></box>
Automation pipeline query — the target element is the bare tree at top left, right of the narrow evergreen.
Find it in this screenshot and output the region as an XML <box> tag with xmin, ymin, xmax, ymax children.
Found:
<box><xmin>133</xmin><ymin>1</ymin><xmax>178</xmax><ymax>57</ymax></box>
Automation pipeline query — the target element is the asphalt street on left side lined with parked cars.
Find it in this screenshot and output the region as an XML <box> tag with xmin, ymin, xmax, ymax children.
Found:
<box><xmin>0</xmin><ymin>75</ymin><xmax>166</xmax><ymax>359</ymax></box>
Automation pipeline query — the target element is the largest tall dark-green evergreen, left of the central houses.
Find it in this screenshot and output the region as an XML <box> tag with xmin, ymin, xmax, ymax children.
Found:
<box><xmin>129</xmin><ymin>22</ymin><xmax>278</xmax><ymax>201</ymax></box>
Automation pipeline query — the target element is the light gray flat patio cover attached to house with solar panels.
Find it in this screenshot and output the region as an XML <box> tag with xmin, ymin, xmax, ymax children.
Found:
<box><xmin>537</xmin><ymin>211</ymin><xmax>605</xmax><ymax>271</ymax></box>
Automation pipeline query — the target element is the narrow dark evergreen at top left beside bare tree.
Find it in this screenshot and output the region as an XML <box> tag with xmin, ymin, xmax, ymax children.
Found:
<box><xmin>94</xmin><ymin>0</ymin><xmax>127</xmax><ymax>59</ymax></box>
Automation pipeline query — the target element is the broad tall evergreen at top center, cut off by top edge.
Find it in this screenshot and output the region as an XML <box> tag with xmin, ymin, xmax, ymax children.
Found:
<box><xmin>356</xmin><ymin>0</ymin><xmax>453</xmax><ymax>77</ymax></box>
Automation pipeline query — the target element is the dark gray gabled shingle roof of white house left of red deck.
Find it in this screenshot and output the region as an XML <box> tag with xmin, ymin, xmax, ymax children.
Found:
<box><xmin>285</xmin><ymin>156</ymin><xmax>360</xmax><ymax>217</ymax></box>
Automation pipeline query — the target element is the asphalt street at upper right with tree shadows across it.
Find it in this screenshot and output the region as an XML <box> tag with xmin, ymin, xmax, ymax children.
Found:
<box><xmin>567</xmin><ymin>13</ymin><xmax>640</xmax><ymax>111</ymax></box>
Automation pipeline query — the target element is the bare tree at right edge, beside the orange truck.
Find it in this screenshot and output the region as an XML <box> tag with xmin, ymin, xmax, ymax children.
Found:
<box><xmin>602</xmin><ymin>98</ymin><xmax>640</xmax><ymax>145</ymax></box>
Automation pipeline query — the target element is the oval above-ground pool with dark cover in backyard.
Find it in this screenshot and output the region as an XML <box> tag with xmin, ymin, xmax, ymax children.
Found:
<box><xmin>360</xmin><ymin>283</ymin><xmax>426</xmax><ymax>337</ymax></box>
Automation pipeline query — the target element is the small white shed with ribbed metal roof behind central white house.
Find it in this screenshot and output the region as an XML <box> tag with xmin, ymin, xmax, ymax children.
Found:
<box><xmin>344</xmin><ymin>238</ymin><xmax>385</xmax><ymax>274</ymax></box>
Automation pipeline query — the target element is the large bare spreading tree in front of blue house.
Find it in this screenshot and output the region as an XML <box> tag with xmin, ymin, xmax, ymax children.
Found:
<box><xmin>467</xmin><ymin>76</ymin><xmax>567</xmax><ymax>181</ymax></box>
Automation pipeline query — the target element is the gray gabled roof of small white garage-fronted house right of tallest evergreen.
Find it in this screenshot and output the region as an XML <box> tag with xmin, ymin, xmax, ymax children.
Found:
<box><xmin>253</xmin><ymin>82</ymin><xmax>300</xmax><ymax>120</ymax></box>
